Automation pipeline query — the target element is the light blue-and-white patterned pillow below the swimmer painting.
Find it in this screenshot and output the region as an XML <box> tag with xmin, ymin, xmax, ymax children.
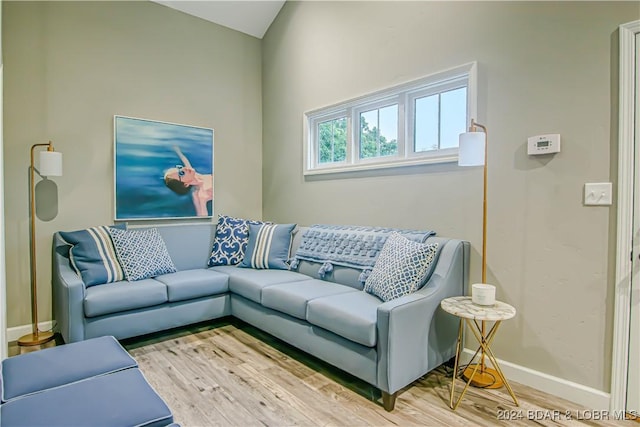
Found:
<box><xmin>109</xmin><ymin>228</ymin><xmax>176</xmax><ymax>282</ymax></box>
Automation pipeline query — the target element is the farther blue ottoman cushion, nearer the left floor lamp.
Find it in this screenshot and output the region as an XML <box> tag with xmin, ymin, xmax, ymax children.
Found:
<box><xmin>1</xmin><ymin>336</ymin><xmax>138</xmax><ymax>402</ymax></box>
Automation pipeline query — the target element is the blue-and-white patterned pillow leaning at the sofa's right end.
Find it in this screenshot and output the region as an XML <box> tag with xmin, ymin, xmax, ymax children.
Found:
<box><xmin>364</xmin><ymin>232</ymin><xmax>438</xmax><ymax>301</ymax></box>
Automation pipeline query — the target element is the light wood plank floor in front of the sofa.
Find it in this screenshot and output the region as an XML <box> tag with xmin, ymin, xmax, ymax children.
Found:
<box><xmin>112</xmin><ymin>319</ymin><xmax>636</xmax><ymax>427</ymax></box>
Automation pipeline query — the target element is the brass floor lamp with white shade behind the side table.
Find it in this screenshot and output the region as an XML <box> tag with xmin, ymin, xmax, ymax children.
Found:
<box><xmin>458</xmin><ymin>119</ymin><xmax>502</xmax><ymax>388</ymax></box>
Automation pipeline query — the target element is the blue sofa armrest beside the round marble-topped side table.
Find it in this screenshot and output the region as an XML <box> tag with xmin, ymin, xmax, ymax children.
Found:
<box><xmin>377</xmin><ymin>240</ymin><xmax>469</xmax><ymax>394</ymax></box>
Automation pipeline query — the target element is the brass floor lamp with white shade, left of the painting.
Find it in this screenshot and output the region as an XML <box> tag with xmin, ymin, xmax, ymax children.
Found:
<box><xmin>18</xmin><ymin>141</ymin><xmax>62</xmax><ymax>346</ymax></box>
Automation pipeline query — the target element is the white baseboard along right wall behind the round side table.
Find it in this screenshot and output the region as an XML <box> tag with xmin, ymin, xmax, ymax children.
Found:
<box><xmin>460</xmin><ymin>348</ymin><xmax>611</xmax><ymax>410</ymax></box>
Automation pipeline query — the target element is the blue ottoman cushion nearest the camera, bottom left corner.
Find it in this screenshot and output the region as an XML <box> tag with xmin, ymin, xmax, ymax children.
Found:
<box><xmin>0</xmin><ymin>368</ymin><xmax>173</xmax><ymax>427</ymax></box>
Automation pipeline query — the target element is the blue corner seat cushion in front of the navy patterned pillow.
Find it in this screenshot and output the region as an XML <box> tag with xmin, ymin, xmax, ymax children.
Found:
<box><xmin>211</xmin><ymin>265</ymin><xmax>312</xmax><ymax>304</ymax></box>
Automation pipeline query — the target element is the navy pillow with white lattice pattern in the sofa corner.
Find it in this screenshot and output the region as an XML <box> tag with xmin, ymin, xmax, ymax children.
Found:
<box><xmin>209</xmin><ymin>215</ymin><xmax>263</xmax><ymax>267</ymax></box>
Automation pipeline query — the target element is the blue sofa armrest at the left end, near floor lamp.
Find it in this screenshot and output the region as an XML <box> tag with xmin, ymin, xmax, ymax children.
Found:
<box><xmin>51</xmin><ymin>234</ymin><xmax>85</xmax><ymax>344</ymax></box>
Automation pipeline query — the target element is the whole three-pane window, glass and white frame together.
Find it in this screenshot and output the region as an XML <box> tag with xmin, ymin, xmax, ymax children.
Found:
<box><xmin>304</xmin><ymin>63</ymin><xmax>476</xmax><ymax>175</ymax></box>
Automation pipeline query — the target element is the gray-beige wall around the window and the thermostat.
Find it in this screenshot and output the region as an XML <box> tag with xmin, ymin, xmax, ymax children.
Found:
<box><xmin>262</xmin><ymin>2</ymin><xmax>640</xmax><ymax>391</ymax></box>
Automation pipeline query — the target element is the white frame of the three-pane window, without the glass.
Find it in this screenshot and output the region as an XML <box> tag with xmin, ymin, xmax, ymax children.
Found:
<box><xmin>303</xmin><ymin>62</ymin><xmax>478</xmax><ymax>175</ymax></box>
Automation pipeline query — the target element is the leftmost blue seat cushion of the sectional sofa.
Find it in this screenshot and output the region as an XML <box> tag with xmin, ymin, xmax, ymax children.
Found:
<box><xmin>84</xmin><ymin>279</ymin><xmax>168</xmax><ymax>317</ymax></box>
